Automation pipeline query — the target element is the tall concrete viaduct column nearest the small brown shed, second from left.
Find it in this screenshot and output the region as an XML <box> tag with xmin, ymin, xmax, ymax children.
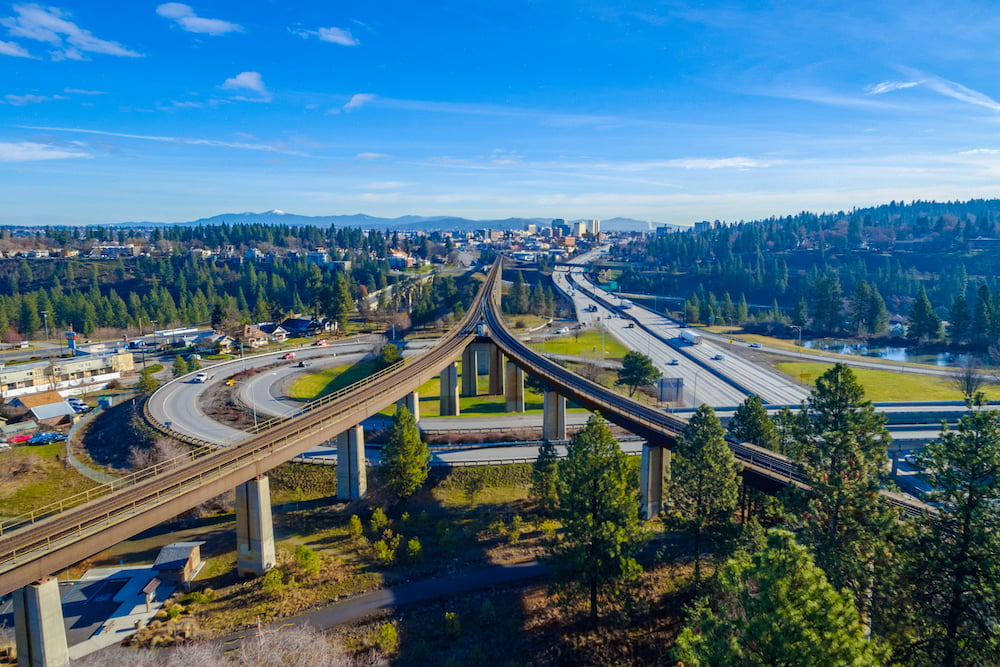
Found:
<box><xmin>236</xmin><ymin>475</ymin><xmax>278</xmax><ymax>577</ymax></box>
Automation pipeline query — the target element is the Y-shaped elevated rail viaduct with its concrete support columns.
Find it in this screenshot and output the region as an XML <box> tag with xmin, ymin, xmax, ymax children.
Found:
<box><xmin>0</xmin><ymin>261</ymin><xmax>924</xmax><ymax>665</ymax></box>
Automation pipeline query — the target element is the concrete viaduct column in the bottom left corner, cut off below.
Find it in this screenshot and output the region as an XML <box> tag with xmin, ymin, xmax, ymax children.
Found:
<box><xmin>14</xmin><ymin>579</ymin><xmax>69</xmax><ymax>667</ymax></box>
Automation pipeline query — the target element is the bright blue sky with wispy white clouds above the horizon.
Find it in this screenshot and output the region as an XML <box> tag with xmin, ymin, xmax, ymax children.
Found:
<box><xmin>0</xmin><ymin>0</ymin><xmax>1000</xmax><ymax>224</ymax></box>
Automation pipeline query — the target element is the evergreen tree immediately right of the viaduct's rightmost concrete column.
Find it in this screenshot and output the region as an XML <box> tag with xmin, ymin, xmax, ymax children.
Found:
<box><xmin>671</xmin><ymin>405</ymin><xmax>739</xmax><ymax>581</ymax></box>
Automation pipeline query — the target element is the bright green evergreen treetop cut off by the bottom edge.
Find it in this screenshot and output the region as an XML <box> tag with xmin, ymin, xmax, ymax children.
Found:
<box><xmin>675</xmin><ymin>530</ymin><xmax>883</xmax><ymax>667</ymax></box>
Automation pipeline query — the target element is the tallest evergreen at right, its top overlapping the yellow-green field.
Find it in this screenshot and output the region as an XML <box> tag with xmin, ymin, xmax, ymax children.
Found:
<box><xmin>798</xmin><ymin>363</ymin><xmax>893</xmax><ymax>611</ymax></box>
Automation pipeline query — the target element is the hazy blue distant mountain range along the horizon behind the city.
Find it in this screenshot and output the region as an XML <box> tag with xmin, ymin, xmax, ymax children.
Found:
<box><xmin>121</xmin><ymin>214</ymin><xmax>676</xmax><ymax>231</ymax></box>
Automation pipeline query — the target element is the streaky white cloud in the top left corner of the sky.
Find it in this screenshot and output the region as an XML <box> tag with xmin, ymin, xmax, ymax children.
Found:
<box><xmin>0</xmin><ymin>4</ymin><xmax>142</xmax><ymax>60</ymax></box>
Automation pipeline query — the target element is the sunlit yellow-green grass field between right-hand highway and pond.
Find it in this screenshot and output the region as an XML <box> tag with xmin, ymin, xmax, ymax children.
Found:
<box><xmin>776</xmin><ymin>362</ymin><xmax>1000</xmax><ymax>401</ymax></box>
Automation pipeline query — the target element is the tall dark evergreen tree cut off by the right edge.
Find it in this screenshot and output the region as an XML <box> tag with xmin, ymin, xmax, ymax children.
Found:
<box><xmin>907</xmin><ymin>393</ymin><xmax>1000</xmax><ymax>667</ymax></box>
